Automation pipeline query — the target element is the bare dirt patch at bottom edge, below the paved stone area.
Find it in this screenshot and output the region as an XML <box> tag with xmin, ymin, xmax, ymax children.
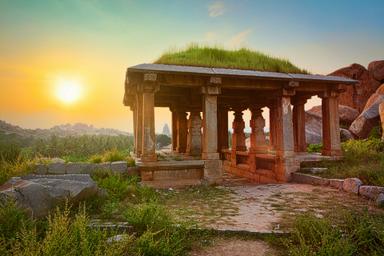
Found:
<box><xmin>189</xmin><ymin>239</ymin><xmax>276</xmax><ymax>256</ymax></box>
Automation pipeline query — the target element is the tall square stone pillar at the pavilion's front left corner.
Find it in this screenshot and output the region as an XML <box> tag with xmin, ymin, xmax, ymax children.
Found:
<box><xmin>141</xmin><ymin>83</ymin><xmax>157</xmax><ymax>162</ymax></box>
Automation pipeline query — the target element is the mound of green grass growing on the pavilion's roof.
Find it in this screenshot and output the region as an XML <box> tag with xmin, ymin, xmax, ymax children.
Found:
<box><xmin>155</xmin><ymin>45</ymin><xmax>308</xmax><ymax>74</ymax></box>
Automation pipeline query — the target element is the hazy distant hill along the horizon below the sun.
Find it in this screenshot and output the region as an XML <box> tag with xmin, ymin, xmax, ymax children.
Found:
<box><xmin>0</xmin><ymin>120</ymin><xmax>131</xmax><ymax>138</ymax></box>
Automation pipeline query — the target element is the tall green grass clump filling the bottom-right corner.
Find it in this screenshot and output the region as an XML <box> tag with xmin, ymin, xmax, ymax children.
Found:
<box><xmin>283</xmin><ymin>210</ymin><xmax>384</xmax><ymax>256</ymax></box>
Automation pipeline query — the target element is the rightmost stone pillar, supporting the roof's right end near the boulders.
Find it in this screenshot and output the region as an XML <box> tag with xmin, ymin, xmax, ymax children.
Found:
<box><xmin>321</xmin><ymin>92</ymin><xmax>342</xmax><ymax>156</ymax></box>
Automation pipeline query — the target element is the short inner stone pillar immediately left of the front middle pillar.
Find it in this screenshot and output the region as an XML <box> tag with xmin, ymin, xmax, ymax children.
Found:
<box><xmin>187</xmin><ymin>111</ymin><xmax>202</xmax><ymax>156</ymax></box>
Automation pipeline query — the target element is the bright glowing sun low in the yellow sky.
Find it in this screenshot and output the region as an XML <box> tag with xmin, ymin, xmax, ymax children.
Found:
<box><xmin>55</xmin><ymin>79</ymin><xmax>83</xmax><ymax>104</ymax></box>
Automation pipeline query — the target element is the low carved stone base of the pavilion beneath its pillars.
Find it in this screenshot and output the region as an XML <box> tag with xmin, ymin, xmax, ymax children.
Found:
<box><xmin>137</xmin><ymin>149</ymin><xmax>340</xmax><ymax>189</ymax></box>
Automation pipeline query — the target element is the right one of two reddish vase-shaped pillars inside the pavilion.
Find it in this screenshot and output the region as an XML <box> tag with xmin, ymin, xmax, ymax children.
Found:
<box><xmin>249</xmin><ymin>107</ymin><xmax>267</xmax><ymax>152</ymax></box>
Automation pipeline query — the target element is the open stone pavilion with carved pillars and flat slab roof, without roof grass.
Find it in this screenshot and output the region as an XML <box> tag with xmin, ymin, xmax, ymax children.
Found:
<box><xmin>124</xmin><ymin>64</ymin><xmax>356</xmax><ymax>187</ymax></box>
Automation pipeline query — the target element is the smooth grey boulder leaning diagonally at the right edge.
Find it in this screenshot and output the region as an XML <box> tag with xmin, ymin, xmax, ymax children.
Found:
<box><xmin>349</xmin><ymin>84</ymin><xmax>384</xmax><ymax>138</ymax></box>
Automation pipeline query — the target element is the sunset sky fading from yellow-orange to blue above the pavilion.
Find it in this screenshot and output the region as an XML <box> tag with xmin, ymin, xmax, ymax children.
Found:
<box><xmin>0</xmin><ymin>0</ymin><xmax>384</xmax><ymax>134</ymax></box>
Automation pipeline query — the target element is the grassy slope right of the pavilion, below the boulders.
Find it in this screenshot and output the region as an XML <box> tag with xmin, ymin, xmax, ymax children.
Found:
<box><xmin>303</xmin><ymin>138</ymin><xmax>384</xmax><ymax>186</ymax></box>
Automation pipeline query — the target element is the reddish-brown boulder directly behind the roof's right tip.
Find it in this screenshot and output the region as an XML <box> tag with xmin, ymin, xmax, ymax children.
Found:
<box><xmin>329</xmin><ymin>63</ymin><xmax>380</xmax><ymax>112</ymax></box>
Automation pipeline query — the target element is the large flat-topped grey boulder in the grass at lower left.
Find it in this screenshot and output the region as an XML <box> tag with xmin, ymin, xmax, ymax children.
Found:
<box><xmin>0</xmin><ymin>174</ymin><xmax>99</xmax><ymax>218</ymax></box>
